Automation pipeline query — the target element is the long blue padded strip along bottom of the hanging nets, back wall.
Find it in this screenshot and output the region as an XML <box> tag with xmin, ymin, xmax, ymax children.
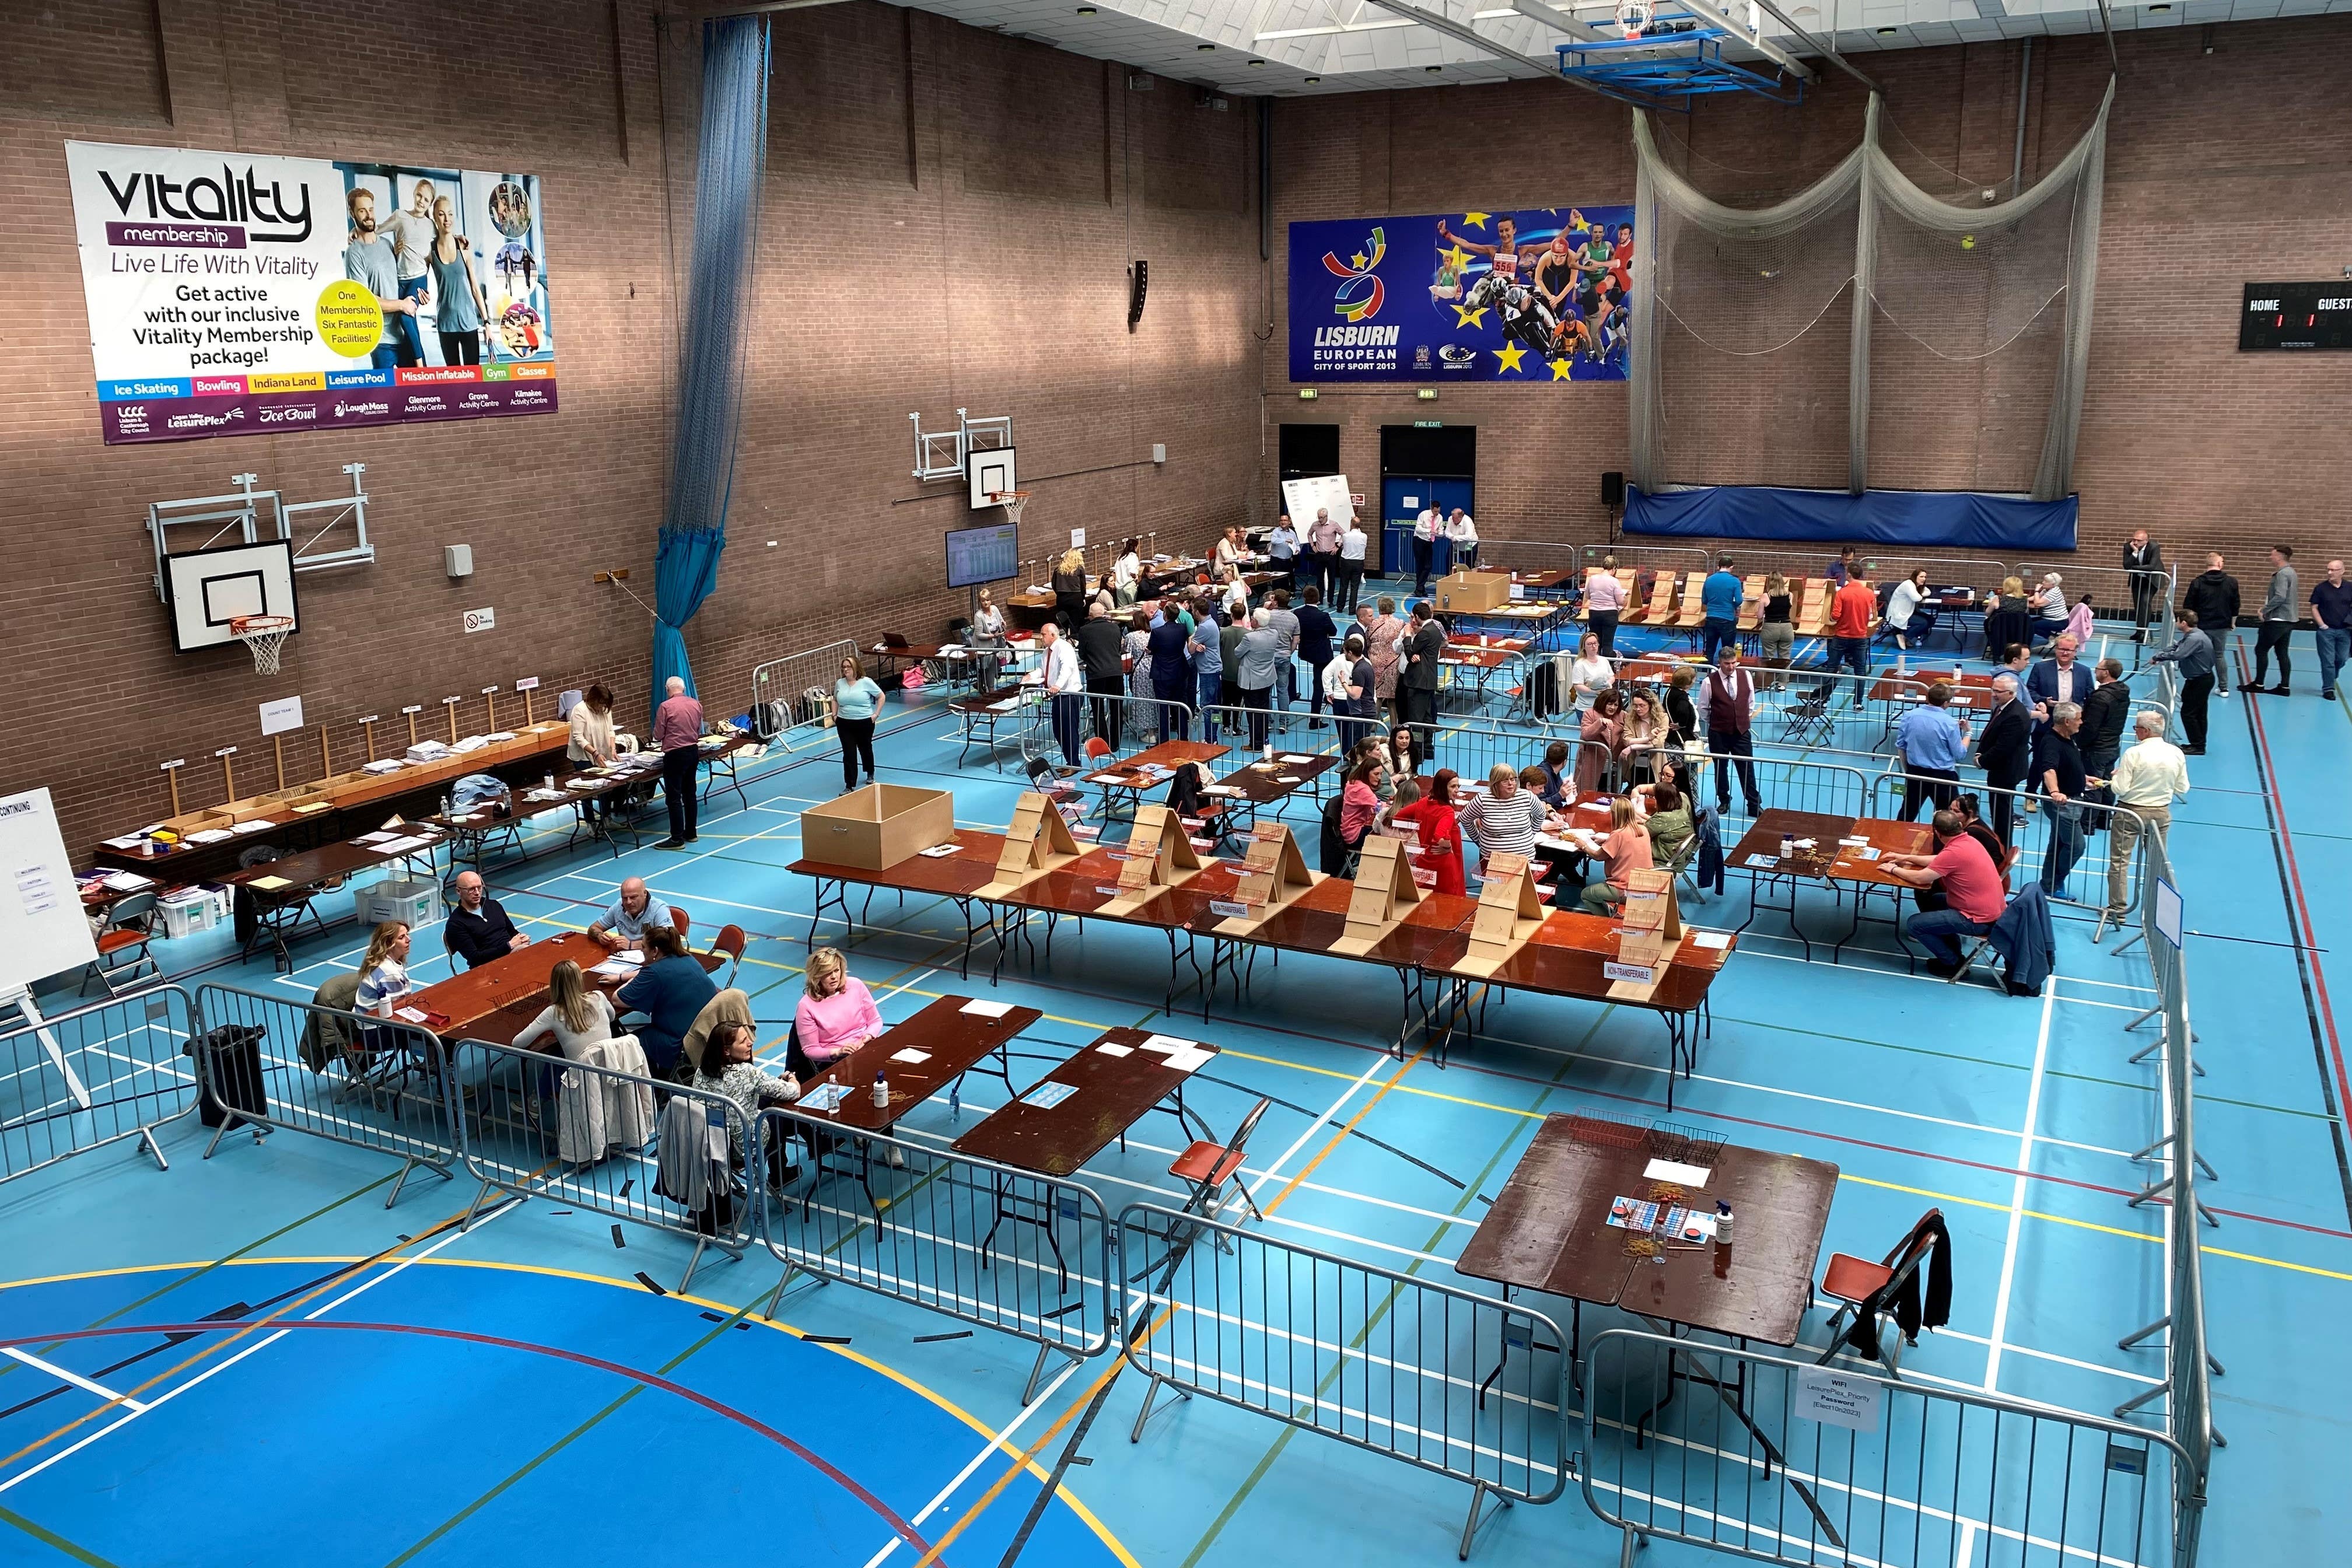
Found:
<box><xmin>1625</xmin><ymin>484</ymin><xmax>2077</xmax><ymax>550</ymax></box>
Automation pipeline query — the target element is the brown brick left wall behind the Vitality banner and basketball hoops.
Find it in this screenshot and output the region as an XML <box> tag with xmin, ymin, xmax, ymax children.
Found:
<box><xmin>0</xmin><ymin>0</ymin><xmax>1261</xmax><ymax>853</ymax></box>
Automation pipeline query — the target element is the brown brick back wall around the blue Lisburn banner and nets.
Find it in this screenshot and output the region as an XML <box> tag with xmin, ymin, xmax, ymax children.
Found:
<box><xmin>1261</xmin><ymin>16</ymin><xmax>2352</xmax><ymax>594</ymax></box>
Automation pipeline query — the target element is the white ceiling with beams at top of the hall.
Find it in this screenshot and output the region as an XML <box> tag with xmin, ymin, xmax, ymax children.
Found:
<box><xmin>891</xmin><ymin>0</ymin><xmax>2352</xmax><ymax>96</ymax></box>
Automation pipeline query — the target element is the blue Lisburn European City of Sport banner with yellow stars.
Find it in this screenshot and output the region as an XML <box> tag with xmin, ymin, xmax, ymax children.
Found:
<box><xmin>1292</xmin><ymin>207</ymin><xmax>1634</xmax><ymax>383</ymax></box>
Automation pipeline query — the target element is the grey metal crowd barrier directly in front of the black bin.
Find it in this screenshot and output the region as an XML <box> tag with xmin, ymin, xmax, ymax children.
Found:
<box><xmin>195</xmin><ymin>985</ymin><xmax>459</xmax><ymax>1208</ymax></box>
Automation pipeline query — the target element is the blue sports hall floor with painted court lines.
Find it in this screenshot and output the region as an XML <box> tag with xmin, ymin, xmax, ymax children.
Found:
<box><xmin>0</xmin><ymin>606</ymin><xmax>2352</xmax><ymax>1568</ymax></box>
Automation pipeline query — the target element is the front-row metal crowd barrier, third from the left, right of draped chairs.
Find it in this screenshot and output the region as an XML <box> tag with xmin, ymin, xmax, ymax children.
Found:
<box><xmin>752</xmin><ymin>1107</ymin><xmax>1115</xmax><ymax>1406</ymax></box>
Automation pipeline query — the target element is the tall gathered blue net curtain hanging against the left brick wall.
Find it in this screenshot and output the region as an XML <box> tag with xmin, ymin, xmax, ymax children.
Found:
<box><xmin>652</xmin><ymin>16</ymin><xmax>766</xmax><ymax>708</ymax></box>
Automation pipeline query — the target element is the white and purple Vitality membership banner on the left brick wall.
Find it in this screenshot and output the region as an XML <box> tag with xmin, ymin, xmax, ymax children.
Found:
<box><xmin>66</xmin><ymin>141</ymin><xmax>555</xmax><ymax>442</ymax></box>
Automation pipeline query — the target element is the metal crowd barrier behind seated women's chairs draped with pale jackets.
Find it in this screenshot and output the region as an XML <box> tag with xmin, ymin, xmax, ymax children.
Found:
<box><xmin>449</xmin><ymin>1039</ymin><xmax>757</xmax><ymax>1290</ymax></box>
